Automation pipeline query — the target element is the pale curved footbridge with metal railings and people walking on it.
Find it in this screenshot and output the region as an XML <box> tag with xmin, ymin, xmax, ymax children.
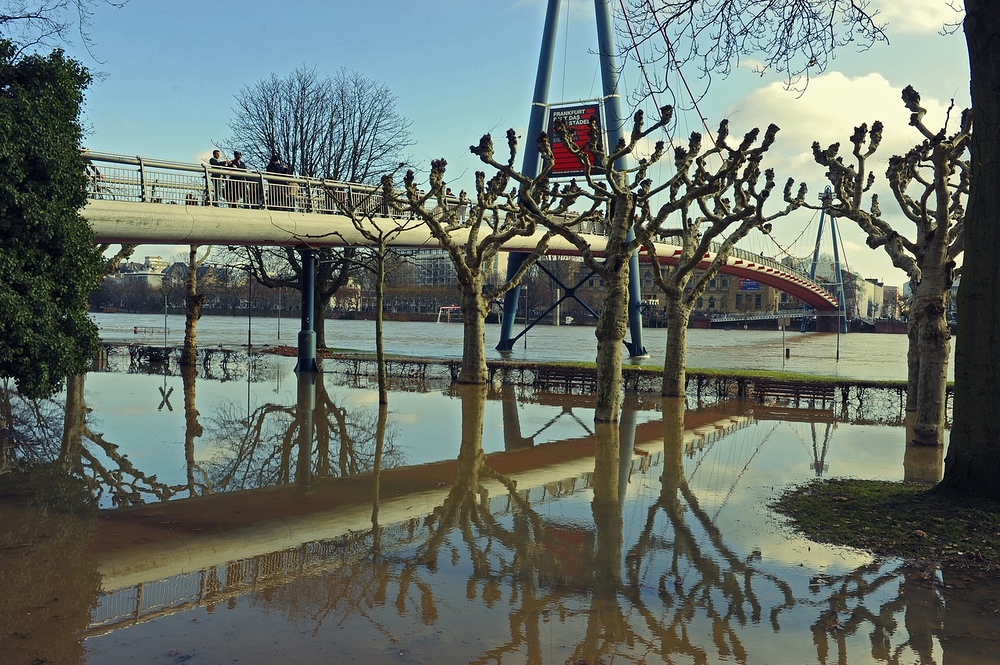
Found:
<box><xmin>83</xmin><ymin>151</ymin><xmax>838</xmax><ymax>311</ymax></box>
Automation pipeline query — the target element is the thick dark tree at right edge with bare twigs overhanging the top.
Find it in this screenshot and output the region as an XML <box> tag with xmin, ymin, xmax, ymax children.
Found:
<box><xmin>612</xmin><ymin>0</ymin><xmax>1000</xmax><ymax>498</ymax></box>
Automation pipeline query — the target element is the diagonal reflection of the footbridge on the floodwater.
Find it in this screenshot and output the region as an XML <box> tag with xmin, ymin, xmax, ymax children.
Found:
<box><xmin>91</xmin><ymin>409</ymin><xmax>751</xmax><ymax>634</ymax></box>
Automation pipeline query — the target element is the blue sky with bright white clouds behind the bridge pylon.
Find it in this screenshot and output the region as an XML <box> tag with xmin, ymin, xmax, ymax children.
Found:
<box><xmin>56</xmin><ymin>0</ymin><xmax>969</xmax><ymax>285</ymax></box>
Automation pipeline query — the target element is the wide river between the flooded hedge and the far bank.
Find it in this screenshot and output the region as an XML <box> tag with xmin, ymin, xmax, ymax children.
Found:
<box><xmin>91</xmin><ymin>314</ymin><xmax>940</xmax><ymax>381</ymax></box>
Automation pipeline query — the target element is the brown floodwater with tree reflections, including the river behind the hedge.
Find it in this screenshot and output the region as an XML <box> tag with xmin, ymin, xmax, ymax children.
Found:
<box><xmin>0</xmin><ymin>315</ymin><xmax>1000</xmax><ymax>665</ymax></box>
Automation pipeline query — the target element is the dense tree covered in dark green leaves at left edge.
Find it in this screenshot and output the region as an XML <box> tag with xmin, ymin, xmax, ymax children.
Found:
<box><xmin>0</xmin><ymin>41</ymin><xmax>103</xmax><ymax>397</ymax></box>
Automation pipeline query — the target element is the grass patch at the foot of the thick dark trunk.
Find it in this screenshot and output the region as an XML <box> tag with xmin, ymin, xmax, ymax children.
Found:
<box><xmin>772</xmin><ymin>479</ymin><xmax>1000</xmax><ymax>571</ymax></box>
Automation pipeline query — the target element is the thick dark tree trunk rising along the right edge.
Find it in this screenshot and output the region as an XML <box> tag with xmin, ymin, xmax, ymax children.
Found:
<box><xmin>939</xmin><ymin>0</ymin><xmax>1000</xmax><ymax>498</ymax></box>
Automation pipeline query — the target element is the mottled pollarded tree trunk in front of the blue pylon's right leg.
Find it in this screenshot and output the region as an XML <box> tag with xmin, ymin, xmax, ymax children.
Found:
<box><xmin>594</xmin><ymin>260</ymin><xmax>628</xmax><ymax>423</ymax></box>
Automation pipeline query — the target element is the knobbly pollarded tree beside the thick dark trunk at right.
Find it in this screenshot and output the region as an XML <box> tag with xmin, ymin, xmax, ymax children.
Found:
<box><xmin>813</xmin><ymin>86</ymin><xmax>972</xmax><ymax>446</ymax></box>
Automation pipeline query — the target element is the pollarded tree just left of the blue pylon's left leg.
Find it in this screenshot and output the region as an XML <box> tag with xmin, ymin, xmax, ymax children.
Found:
<box><xmin>392</xmin><ymin>157</ymin><xmax>565</xmax><ymax>383</ymax></box>
